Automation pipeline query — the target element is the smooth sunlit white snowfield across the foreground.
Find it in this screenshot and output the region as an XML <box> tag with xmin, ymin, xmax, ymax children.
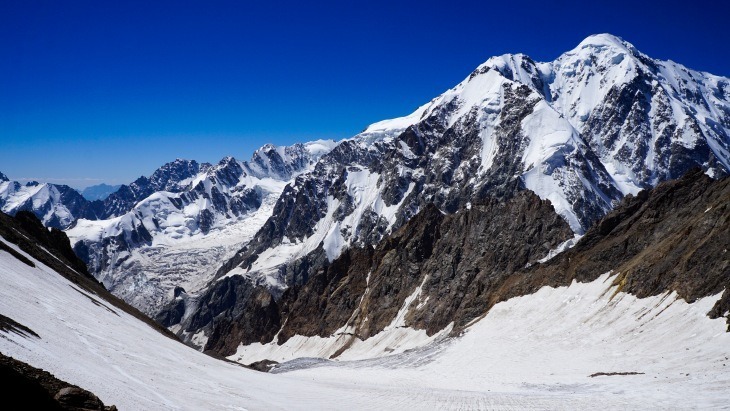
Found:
<box><xmin>0</xmin><ymin>241</ymin><xmax>730</xmax><ymax>410</ymax></box>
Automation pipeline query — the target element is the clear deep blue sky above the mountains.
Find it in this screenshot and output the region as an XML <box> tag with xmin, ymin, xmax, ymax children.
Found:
<box><xmin>0</xmin><ymin>0</ymin><xmax>730</xmax><ymax>187</ymax></box>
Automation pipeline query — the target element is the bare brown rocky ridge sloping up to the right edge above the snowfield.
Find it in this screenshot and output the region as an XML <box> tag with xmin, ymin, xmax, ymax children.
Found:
<box><xmin>500</xmin><ymin>169</ymin><xmax>730</xmax><ymax>325</ymax></box>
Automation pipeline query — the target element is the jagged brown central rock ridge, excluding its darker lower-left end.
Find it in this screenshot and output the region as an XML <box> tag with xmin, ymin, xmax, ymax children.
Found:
<box><xmin>272</xmin><ymin>191</ymin><xmax>572</xmax><ymax>343</ymax></box>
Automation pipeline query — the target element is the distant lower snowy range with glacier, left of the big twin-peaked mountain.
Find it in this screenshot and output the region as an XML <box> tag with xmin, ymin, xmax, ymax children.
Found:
<box><xmin>67</xmin><ymin>140</ymin><xmax>335</xmax><ymax>313</ymax></box>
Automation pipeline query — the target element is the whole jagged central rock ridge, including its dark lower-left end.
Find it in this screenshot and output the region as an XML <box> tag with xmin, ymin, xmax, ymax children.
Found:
<box><xmin>188</xmin><ymin>191</ymin><xmax>572</xmax><ymax>355</ymax></box>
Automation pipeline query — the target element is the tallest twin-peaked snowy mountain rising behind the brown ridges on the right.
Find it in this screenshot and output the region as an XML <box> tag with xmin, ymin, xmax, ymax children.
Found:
<box><xmin>213</xmin><ymin>34</ymin><xmax>730</xmax><ymax>295</ymax></box>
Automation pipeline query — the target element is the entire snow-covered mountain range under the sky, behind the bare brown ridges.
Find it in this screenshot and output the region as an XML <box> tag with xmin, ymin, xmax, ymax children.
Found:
<box><xmin>0</xmin><ymin>34</ymin><xmax>730</xmax><ymax>348</ymax></box>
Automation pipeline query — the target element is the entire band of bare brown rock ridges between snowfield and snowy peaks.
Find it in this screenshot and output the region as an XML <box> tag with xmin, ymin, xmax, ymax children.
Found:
<box><xmin>169</xmin><ymin>170</ymin><xmax>730</xmax><ymax>355</ymax></box>
